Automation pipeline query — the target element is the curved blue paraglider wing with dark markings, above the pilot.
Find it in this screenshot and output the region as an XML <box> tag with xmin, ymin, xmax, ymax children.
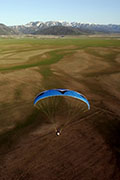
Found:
<box><xmin>34</xmin><ymin>89</ymin><xmax>90</xmax><ymax>109</ymax></box>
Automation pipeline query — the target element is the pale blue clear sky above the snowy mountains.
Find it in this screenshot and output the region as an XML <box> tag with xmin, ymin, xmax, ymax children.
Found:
<box><xmin>0</xmin><ymin>0</ymin><xmax>120</xmax><ymax>25</ymax></box>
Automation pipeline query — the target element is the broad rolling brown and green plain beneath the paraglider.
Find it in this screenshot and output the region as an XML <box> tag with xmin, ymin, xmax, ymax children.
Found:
<box><xmin>0</xmin><ymin>37</ymin><xmax>120</xmax><ymax>180</ymax></box>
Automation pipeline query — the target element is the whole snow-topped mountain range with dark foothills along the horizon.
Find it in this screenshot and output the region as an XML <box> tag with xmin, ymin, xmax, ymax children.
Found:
<box><xmin>0</xmin><ymin>21</ymin><xmax>120</xmax><ymax>35</ymax></box>
